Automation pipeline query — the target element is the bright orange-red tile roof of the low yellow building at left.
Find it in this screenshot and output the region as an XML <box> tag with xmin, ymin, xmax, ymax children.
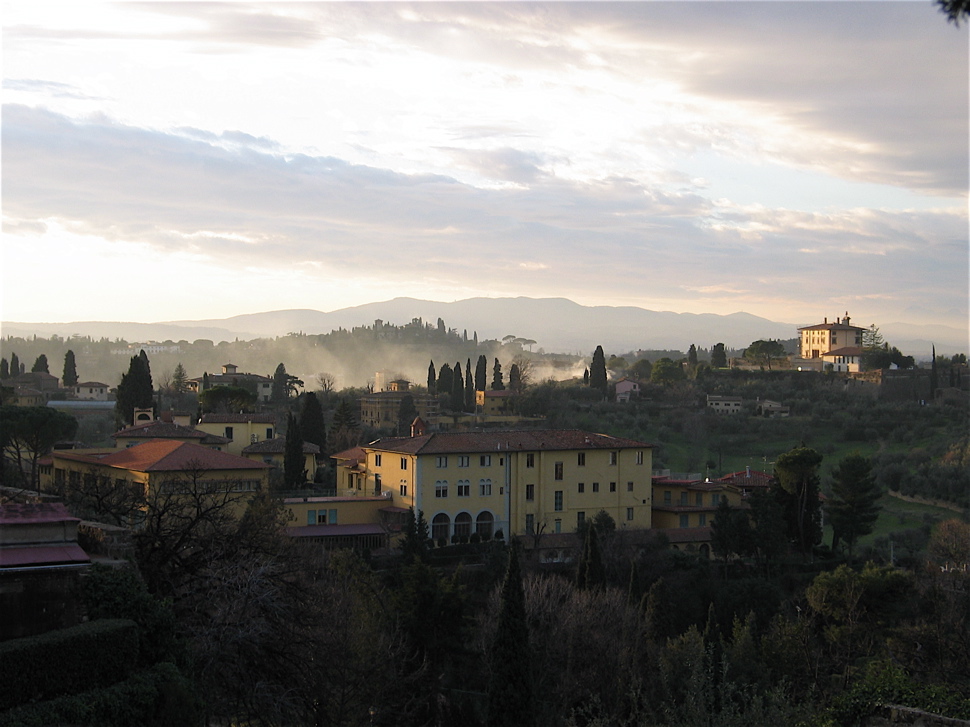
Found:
<box><xmin>54</xmin><ymin>439</ymin><xmax>270</xmax><ymax>472</ymax></box>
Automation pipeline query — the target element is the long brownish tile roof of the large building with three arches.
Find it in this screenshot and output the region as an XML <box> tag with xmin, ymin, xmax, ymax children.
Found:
<box><xmin>364</xmin><ymin>429</ymin><xmax>653</xmax><ymax>454</ymax></box>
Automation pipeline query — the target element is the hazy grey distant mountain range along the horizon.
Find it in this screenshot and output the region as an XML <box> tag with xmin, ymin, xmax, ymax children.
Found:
<box><xmin>2</xmin><ymin>298</ymin><xmax>968</xmax><ymax>358</ymax></box>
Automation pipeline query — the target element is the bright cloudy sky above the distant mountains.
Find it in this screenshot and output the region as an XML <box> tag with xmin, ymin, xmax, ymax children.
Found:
<box><xmin>0</xmin><ymin>0</ymin><xmax>970</xmax><ymax>330</ymax></box>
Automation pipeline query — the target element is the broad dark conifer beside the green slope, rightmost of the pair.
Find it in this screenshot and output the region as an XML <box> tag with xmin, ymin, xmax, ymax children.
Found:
<box><xmin>825</xmin><ymin>453</ymin><xmax>882</xmax><ymax>560</ymax></box>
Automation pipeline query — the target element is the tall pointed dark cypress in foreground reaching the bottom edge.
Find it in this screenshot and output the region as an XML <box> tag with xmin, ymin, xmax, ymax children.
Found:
<box><xmin>487</xmin><ymin>540</ymin><xmax>535</xmax><ymax>727</ymax></box>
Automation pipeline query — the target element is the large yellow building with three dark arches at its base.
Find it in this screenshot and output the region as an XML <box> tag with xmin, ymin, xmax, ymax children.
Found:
<box><xmin>335</xmin><ymin>430</ymin><xmax>652</xmax><ymax>541</ymax></box>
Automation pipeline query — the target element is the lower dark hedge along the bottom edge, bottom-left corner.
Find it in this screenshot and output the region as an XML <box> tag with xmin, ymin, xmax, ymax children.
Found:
<box><xmin>0</xmin><ymin>662</ymin><xmax>202</xmax><ymax>727</ymax></box>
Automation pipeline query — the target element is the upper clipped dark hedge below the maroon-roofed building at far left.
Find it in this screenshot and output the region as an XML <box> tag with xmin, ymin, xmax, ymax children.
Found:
<box><xmin>0</xmin><ymin>619</ymin><xmax>138</xmax><ymax>710</ymax></box>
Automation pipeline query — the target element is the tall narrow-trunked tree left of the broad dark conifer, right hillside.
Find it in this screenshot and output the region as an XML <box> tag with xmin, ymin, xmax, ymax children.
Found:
<box><xmin>775</xmin><ymin>447</ymin><xmax>822</xmax><ymax>559</ymax></box>
